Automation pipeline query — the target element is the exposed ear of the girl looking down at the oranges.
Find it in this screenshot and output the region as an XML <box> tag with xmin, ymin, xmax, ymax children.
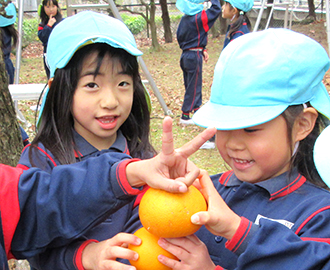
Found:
<box><xmin>295</xmin><ymin>107</ymin><xmax>319</xmax><ymax>141</ymax></box>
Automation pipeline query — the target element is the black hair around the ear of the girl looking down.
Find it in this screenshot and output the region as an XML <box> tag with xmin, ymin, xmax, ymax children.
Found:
<box><xmin>282</xmin><ymin>103</ymin><xmax>329</xmax><ymax>189</ymax></box>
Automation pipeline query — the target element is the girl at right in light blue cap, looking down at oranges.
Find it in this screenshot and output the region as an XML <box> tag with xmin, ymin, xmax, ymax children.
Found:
<box><xmin>159</xmin><ymin>29</ymin><xmax>330</xmax><ymax>270</ymax></box>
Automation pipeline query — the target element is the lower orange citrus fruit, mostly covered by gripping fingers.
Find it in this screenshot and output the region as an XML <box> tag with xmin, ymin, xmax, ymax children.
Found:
<box><xmin>128</xmin><ymin>227</ymin><xmax>177</xmax><ymax>270</ymax></box>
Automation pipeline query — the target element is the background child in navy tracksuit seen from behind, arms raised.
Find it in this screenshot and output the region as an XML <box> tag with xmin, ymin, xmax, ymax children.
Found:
<box><xmin>176</xmin><ymin>0</ymin><xmax>221</xmax><ymax>125</ymax></box>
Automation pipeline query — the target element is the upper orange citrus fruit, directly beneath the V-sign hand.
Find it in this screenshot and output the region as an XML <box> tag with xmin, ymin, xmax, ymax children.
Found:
<box><xmin>139</xmin><ymin>186</ymin><xmax>207</xmax><ymax>238</ymax></box>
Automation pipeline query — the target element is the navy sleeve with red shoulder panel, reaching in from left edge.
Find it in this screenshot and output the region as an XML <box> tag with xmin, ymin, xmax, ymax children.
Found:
<box><xmin>0</xmin><ymin>153</ymin><xmax>141</xmax><ymax>259</ymax></box>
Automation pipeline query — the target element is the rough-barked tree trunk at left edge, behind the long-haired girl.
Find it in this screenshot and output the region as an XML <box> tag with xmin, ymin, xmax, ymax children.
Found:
<box><xmin>0</xmin><ymin>34</ymin><xmax>23</xmax><ymax>166</ymax></box>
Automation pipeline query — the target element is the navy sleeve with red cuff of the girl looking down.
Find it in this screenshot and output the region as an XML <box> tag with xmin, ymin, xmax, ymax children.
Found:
<box><xmin>226</xmin><ymin>218</ymin><xmax>330</xmax><ymax>270</ymax></box>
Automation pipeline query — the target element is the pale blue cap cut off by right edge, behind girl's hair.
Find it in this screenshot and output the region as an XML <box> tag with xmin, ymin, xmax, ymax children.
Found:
<box><xmin>313</xmin><ymin>126</ymin><xmax>330</xmax><ymax>187</ymax></box>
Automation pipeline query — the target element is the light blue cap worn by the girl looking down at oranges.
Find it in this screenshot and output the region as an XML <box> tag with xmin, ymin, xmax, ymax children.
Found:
<box><xmin>193</xmin><ymin>29</ymin><xmax>330</xmax><ymax>130</ymax></box>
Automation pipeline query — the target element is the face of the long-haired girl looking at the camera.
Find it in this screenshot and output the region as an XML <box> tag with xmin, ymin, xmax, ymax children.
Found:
<box><xmin>72</xmin><ymin>53</ymin><xmax>133</xmax><ymax>150</ymax></box>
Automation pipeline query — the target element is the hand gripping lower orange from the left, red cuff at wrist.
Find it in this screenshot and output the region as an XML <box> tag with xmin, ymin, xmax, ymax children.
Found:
<box><xmin>82</xmin><ymin>233</ymin><xmax>141</xmax><ymax>270</ymax></box>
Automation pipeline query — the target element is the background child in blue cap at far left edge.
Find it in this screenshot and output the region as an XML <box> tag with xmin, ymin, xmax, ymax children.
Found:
<box><xmin>0</xmin><ymin>3</ymin><xmax>18</xmax><ymax>84</ymax></box>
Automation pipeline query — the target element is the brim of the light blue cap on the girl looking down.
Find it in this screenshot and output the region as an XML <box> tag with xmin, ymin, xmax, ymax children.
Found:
<box><xmin>192</xmin><ymin>101</ymin><xmax>288</xmax><ymax>130</ymax></box>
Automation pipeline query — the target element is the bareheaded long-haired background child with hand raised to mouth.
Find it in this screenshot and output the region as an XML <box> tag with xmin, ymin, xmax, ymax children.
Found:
<box><xmin>38</xmin><ymin>0</ymin><xmax>62</xmax><ymax>79</ymax></box>
